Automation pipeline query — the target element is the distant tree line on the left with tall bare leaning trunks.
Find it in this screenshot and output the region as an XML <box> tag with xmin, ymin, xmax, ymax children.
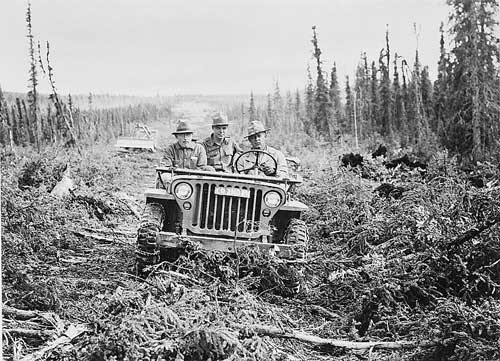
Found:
<box><xmin>0</xmin><ymin>3</ymin><xmax>171</xmax><ymax>149</ymax></box>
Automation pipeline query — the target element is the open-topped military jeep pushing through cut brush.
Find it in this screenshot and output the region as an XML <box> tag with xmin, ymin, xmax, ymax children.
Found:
<box><xmin>136</xmin><ymin>151</ymin><xmax>309</xmax><ymax>275</ymax></box>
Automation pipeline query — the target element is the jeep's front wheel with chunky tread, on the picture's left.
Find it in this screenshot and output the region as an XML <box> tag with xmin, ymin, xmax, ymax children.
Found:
<box><xmin>135</xmin><ymin>203</ymin><xmax>165</xmax><ymax>277</ymax></box>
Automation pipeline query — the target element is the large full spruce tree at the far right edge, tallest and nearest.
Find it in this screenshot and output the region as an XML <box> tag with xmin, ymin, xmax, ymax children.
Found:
<box><xmin>446</xmin><ymin>0</ymin><xmax>500</xmax><ymax>162</ymax></box>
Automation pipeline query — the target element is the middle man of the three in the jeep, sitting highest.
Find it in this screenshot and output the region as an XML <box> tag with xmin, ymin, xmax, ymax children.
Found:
<box><xmin>201</xmin><ymin>113</ymin><xmax>242</xmax><ymax>172</ymax></box>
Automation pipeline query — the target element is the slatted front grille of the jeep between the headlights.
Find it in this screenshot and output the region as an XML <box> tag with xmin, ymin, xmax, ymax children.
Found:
<box><xmin>192</xmin><ymin>183</ymin><xmax>262</xmax><ymax>237</ymax></box>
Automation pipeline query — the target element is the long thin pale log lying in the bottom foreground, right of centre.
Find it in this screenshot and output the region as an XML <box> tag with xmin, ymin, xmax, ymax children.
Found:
<box><xmin>234</xmin><ymin>324</ymin><xmax>436</xmax><ymax>350</ymax></box>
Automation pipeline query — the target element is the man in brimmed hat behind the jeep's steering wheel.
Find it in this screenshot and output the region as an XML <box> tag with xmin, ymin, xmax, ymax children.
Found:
<box><xmin>242</xmin><ymin>120</ymin><xmax>288</xmax><ymax>178</ymax></box>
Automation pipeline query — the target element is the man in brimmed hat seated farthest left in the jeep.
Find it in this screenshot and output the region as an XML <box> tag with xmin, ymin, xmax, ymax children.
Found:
<box><xmin>164</xmin><ymin>119</ymin><xmax>213</xmax><ymax>170</ymax></box>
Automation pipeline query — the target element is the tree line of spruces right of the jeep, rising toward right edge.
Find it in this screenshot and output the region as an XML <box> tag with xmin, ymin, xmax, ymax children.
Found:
<box><xmin>242</xmin><ymin>0</ymin><xmax>500</xmax><ymax>162</ymax></box>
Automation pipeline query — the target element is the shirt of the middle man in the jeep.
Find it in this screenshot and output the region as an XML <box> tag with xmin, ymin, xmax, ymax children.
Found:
<box><xmin>201</xmin><ymin>134</ymin><xmax>242</xmax><ymax>172</ymax></box>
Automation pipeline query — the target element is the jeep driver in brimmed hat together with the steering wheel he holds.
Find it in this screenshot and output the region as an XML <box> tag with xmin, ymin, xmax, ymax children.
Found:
<box><xmin>236</xmin><ymin>120</ymin><xmax>288</xmax><ymax>178</ymax></box>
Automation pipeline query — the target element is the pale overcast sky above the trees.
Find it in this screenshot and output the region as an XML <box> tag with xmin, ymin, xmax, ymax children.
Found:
<box><xmin>0</xmin><ymin>0</ymin><xmax>458</xmax><ymax>95</ymax></box>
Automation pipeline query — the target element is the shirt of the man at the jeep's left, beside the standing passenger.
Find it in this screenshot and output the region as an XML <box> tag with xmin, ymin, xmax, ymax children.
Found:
<box><xmin>163</xmin><ymin>142</ymin><xmax>207</xmax><ymax>169</ymax></box>
